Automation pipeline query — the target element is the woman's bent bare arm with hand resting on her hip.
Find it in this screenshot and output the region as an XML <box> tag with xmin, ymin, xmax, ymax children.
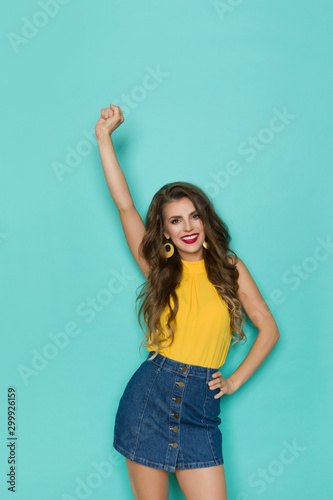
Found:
<box><xmin>209</xmin><ymin>258</ymin><xmax>280</xmax><ymax>398</ymax></box>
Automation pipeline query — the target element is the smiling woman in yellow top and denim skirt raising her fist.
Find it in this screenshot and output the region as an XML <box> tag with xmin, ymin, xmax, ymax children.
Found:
<box><xmin>95</xmin><ymin>104</ymin><xmax>280</xmax><ymax>500</ymax></box>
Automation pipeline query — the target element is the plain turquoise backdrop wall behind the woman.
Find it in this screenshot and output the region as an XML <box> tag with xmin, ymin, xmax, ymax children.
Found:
<box><xmin>0</xmin><ymin>0</ymin><xmax>333</xmax><ymax>500</ymax></box>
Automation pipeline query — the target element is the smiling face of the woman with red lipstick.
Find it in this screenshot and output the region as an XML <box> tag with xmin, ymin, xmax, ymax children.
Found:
<box><xmin>163</xmin><ymin>198</ymin><xmax>205</xmax><ymax>261</ymax></box>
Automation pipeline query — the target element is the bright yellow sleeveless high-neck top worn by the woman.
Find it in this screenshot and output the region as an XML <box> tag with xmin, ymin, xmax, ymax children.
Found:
<box><xmin>147</xmin><ymin>259</ymin><xmax>232</xmax><ymax>369</ymax></box>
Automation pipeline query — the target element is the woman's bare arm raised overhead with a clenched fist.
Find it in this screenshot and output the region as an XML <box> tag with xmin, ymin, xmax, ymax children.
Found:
<box><xmin>95</xmin><ymin>104</ymin><xmax>149</xmax><ymax>277</ymax></box>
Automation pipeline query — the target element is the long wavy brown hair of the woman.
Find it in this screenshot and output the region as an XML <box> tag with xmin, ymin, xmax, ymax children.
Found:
<box><xmin>136</xmin><ymin>182</ymin><xmax>247</xmax><ymax>359</ymax></box>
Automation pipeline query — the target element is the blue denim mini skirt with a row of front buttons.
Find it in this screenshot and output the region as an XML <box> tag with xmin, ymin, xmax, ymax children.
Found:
<box><xmin>113</xmin><ymin>351</ymin><xmax>224</xmax><ymax>472</ymax></box>
